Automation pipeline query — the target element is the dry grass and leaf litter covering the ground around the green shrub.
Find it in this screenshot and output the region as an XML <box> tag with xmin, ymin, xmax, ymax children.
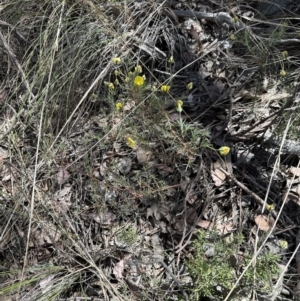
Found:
<box><xmin>0</xmin><ymin>0</ymin><xmax>299</xmax><ymax>300</ymax></box>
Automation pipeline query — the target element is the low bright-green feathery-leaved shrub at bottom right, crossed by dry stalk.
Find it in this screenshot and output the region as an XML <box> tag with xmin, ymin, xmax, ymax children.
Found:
<box><xmin>186</xmin><ymin>231</ymin><xmax>279</xmax><ymax>300</ymax></box>
